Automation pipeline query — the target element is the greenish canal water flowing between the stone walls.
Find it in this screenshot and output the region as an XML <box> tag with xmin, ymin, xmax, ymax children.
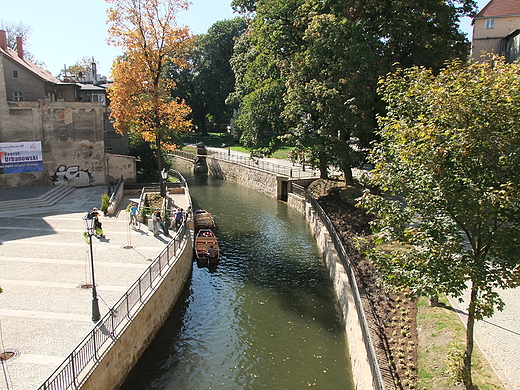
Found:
<box><xmin>120</xmin><ymin>167</ymin><xmax>354</xmax><ymax>390</ymax></box>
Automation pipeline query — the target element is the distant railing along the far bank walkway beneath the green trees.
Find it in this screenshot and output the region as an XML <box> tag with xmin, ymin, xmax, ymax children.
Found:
<box><xmin>173</xmin><ymin>150</ymin><xmax>317</xmax><ymax>179</ymax></box>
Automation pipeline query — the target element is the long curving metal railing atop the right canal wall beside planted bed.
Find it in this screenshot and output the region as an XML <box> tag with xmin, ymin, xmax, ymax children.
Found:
<box><xmin>292</xmin><ymin>184</ymin><xmax>385</xmax><ymax>390</ymax></box>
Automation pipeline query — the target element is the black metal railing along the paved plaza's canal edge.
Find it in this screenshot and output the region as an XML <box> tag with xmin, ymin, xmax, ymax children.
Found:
<box><xmin>38</xmin><ymin>216</ymin><xmax>189</xmax><ymax>390</ymax></box>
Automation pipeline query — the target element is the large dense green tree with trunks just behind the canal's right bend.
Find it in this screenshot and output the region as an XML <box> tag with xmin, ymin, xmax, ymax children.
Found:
<box><xmin>284</xmin><ymin>12</ymin><xmax>378</xmax><ymax>184</ymax></box>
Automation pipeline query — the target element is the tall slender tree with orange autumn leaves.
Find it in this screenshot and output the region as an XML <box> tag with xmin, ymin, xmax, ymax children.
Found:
<box><xmin>106</xmin><ymin>0</ymin><xmax>193</xmax><ymax>180</ymax></box>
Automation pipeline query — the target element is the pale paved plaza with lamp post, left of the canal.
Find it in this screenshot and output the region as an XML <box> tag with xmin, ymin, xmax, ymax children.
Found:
<box><xmin>0</xmin><ymin>187</ymin><xmax>182</xmax><ymax>390</ymax></box>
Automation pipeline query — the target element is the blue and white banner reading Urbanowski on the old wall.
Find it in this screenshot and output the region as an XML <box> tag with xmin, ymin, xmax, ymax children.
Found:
<box><xmin>0</xmin><ymin>141</ymin><xmax>43</xmax><ymax>174</ymax></box>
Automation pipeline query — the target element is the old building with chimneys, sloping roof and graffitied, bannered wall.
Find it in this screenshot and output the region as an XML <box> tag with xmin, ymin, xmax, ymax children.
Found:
<box><xmin>0</xmin><ymin>30</ymin><xmax>135</xmax><ymax>187</ymax></box>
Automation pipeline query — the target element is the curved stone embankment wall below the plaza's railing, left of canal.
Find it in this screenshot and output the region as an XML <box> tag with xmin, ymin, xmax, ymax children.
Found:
<box><xmin>81</xmin><ymin>236</ymin><xmax>193</xmax><ymax>390</ymax></box>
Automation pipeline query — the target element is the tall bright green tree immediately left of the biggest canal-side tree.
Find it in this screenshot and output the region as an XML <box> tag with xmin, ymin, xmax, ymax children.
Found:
<box><xmin>228</xmin><ymin>0</ymin><xmax>305</xmax><ymax>156</ymax></box>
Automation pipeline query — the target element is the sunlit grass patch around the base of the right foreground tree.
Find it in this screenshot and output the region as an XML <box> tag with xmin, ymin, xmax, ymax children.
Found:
<box><xmin>417</xmin><ymin>296</ymin><xmax>504</xmax><ymax>390</ymax></box>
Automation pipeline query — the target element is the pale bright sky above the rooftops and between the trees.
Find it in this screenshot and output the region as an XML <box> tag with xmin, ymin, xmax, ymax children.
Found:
<box><xmin>0</xmin><ymin>0</ymin><xmax>489</xmax><ymax>77</ymax></box>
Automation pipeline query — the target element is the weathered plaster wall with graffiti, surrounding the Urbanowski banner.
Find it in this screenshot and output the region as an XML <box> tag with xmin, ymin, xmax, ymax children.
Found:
<box><xmin>0</xmin><ymin>99</ymin><xmax>107</xmax><ymax>187</ymax></box>
